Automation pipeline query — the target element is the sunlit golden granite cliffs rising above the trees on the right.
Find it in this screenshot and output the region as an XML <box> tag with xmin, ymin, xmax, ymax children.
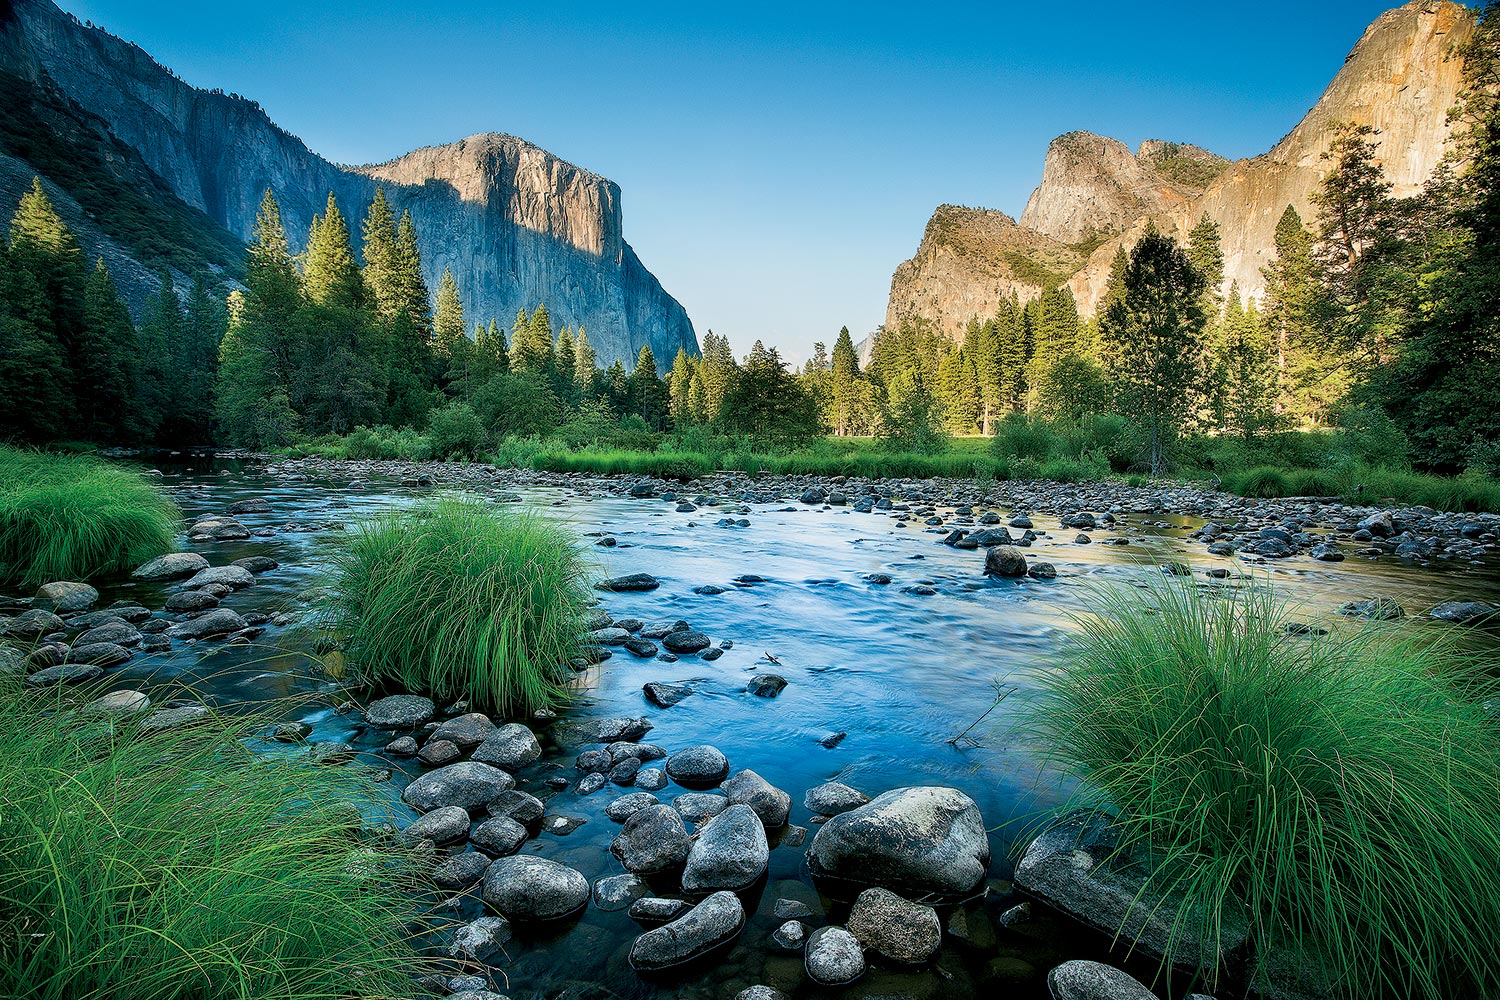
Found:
<box><xmin>887</xmin><ymin>0</ymin><xmax>1475</xmax><ymax>333</ymax></box>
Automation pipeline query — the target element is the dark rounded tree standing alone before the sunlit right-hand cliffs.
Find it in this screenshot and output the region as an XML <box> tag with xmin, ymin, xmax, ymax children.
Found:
<box><xmin>1101</xmin><ymin>226</ymin><xmax>1206</xmax><ymax>474</ymax></box>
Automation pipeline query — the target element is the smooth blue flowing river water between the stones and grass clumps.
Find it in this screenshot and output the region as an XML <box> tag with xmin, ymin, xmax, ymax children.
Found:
<box><xmin>87</xmin><ymin>462</ymin><xmax>1500</xmax><ymax>999</ymax></box>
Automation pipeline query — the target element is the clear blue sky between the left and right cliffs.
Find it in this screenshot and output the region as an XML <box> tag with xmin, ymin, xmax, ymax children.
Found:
<box><xmin>63</xmin><ymin>0</ymin><xmax>1394</xmax><ymax>360</ymax></box>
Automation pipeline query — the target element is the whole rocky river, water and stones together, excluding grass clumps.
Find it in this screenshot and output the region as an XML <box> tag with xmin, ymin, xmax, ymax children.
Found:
<box><xmin>0</xmin><ymin>459</ymin><xmax>1500</xmax><ymax>1000</ymax></box>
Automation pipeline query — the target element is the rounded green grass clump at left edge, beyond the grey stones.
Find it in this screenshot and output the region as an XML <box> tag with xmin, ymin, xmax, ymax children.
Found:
<box><xmin>0</xmin><ymin>447</ymin><xmax>177</xmax><ymax>586</ymax></box>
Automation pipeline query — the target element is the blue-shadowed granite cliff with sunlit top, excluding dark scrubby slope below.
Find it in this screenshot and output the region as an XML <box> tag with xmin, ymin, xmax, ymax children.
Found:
<box><xmin>0</xmin><ymin>0</ymin><xmax>698</xmax><ymax>364</ymax></box>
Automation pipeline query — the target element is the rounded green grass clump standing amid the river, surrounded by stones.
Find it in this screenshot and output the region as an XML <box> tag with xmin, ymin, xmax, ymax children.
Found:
<box><xmin>318</xmin><ymin>498</ymin><xmax>590</xmax><ymax>715</ymax></box>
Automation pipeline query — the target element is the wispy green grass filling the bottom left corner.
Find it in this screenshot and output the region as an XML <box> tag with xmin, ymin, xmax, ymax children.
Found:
<box><xmin>0</xmin><ymin>681</ymin><xmax>428</xmax><ymax>1000</ymax></box>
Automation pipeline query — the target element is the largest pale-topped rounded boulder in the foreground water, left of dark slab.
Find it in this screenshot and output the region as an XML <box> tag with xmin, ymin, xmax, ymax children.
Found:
<box><xmin>807</xmin><ymin>786</ymin><xmax>990</xmax><ymax>897</ymax></box>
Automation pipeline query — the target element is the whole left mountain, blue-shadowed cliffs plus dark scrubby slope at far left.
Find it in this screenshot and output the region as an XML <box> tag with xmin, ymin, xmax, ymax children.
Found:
<box><xmin>0</xmin><ymin>0</ymin><xmax>698</xmax><ymax>364</ymax></box>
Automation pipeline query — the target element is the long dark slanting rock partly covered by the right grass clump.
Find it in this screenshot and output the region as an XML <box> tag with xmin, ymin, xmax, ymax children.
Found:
<box><xmin>1014</xmin><ymin>810</ymin><xmax>1250</xmax><ymax>966</ymax></box>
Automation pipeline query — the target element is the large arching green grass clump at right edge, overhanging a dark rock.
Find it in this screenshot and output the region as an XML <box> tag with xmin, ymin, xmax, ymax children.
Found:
<box><xmin>1035</xmin><ymin>583</ymin><xmax>1500</xmax><ymax>999</ymax></box>
